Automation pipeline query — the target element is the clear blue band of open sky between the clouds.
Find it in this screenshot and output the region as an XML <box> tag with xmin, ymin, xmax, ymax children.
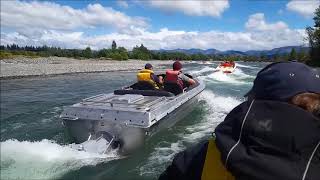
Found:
<box><xmin>55</xmin><ymin>0</ymin><xmax>313</xmax><ymax>32</ymax></box>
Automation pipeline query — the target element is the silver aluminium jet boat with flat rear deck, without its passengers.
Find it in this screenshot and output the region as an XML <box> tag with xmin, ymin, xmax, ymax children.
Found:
<box><xmin>60</xmin><ymin>78</ymin><xmax>205</xmax><ymax>154</ymax></box>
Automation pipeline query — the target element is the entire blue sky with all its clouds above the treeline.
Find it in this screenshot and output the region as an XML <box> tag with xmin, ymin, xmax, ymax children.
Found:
<box><xmin>1</xmin><ymin>0</ymin><xmax>320</xmax><ymax>51</ymax></box>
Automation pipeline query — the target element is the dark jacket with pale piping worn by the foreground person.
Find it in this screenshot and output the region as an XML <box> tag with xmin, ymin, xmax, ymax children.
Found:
<box><xmin>160</xmin><ymin>100</ymin><xmax>320</xmax><ymax>180</ymax></box>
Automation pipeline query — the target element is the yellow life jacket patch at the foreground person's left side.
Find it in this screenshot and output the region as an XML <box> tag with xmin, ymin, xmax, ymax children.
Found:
<box><xmin>201</xmin><ymin>139</ymin><xmax>235</xmax><ymax>180</ymax></box>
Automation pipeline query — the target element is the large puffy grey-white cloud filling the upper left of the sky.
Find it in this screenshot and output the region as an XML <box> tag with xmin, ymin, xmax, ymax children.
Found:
<box><xmin>1</xmin><ymin>1</ymin><xmax>147</xmax><ymax>30</ymax></box>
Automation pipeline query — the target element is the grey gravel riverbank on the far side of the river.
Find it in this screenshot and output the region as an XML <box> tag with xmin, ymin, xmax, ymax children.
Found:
<box><xmin>0</xmin><ymin>57</ymin><xmax>173</xmax><ymax>78</ymax></box>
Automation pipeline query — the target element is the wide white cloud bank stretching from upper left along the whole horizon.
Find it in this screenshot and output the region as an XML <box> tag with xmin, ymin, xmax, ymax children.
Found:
<box><xmin>1</xmin><ymin>1</ymin><xmax>305</xmax><ymax>51</ymax></box>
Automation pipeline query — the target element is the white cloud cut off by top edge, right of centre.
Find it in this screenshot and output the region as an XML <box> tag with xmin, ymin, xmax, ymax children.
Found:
<box><xmin>143</xmin><ymin>0</ymin><xmax>229</xmax><ymax>17</ymax></box>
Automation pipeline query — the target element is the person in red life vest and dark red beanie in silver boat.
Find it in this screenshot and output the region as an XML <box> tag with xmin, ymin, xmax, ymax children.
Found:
<box><xmin>164</xmin><ymin>61</ymin><xmax>196</xmax><ymax>95</ymax></box>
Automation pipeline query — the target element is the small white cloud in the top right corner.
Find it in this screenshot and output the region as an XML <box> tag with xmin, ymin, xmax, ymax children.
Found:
<box><xmin>287</xmin><ymin>0</ymin><xmax>320</xmax><ymax>17</ymax></box>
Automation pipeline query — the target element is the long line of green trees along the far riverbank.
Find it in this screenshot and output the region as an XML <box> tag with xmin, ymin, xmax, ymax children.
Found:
<box><xmin>0</xmin><ymin>41</ymin><xmax>310</xmax><ymax>62</ymax></box>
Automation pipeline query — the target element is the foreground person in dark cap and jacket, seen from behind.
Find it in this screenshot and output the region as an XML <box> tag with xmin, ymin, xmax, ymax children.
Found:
<box><xmin>159</xmin><ymin>62</ymin><xmax>320</xmax><ymax>180</ymax></box>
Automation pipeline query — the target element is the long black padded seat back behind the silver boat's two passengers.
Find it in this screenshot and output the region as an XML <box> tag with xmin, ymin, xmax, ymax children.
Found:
<box><xmin>113</xmin><ymin>89</ymin><xmax>174</xmax><ymax>97</ymax></box>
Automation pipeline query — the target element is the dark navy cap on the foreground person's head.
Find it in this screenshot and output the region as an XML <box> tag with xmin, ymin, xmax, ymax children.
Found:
<box><xmin>245</xmin><ymin>62</ymin><xmax>320</xmax><ymax>101</ymax></box>
